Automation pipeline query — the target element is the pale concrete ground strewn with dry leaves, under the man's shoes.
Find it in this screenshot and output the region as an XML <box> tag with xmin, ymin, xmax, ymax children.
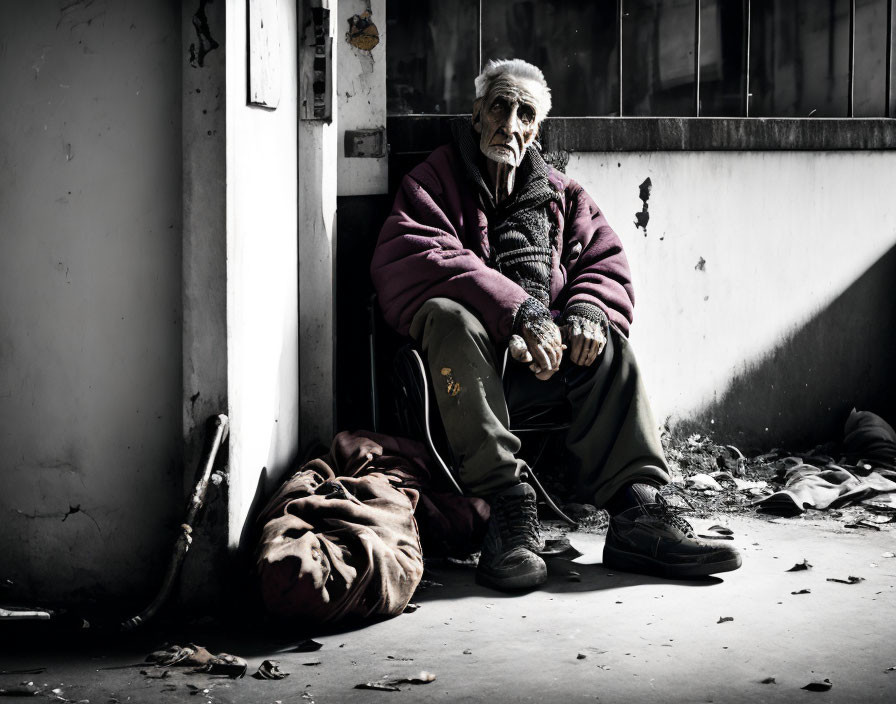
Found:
<box><xmin>0</xmin><ymin>517</ymin><xmax>896</xmax><ymax>704</ymax></box>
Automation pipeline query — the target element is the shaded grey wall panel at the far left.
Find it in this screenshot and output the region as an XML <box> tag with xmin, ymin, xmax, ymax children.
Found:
<box><xmin>0</xmin><ymin>0</ymin><xmax>183</xmax><ymax>602</ymax></box>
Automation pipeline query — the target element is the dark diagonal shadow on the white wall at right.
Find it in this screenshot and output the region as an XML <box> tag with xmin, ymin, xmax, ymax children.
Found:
<box><xmin>675</xmin><ymin>246</ymin><xmax>896</xmax><ymax>450</ymax></box>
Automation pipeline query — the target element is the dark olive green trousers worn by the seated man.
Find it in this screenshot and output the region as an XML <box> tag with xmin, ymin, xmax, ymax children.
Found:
<box><xmin>411</xmin><ymin>298</ymin><xmax>669</xmax><ymax>507</ymax></box>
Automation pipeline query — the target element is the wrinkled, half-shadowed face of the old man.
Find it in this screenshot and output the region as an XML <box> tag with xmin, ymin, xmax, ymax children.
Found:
<box><xmin>473</xmin><ymin>76</ymin><xmax>542</xmax><ymax>166</ymax></box>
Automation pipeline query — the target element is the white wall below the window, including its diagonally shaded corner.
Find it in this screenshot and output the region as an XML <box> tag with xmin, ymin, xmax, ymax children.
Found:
<box><xmin>567</xmin><ymin>151</ymin><xmax>896</xmax><ymax>447</ymax></box>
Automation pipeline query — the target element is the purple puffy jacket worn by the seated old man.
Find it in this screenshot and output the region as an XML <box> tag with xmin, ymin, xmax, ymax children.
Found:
<box><xmin>370</xmin><ymin>144</ymin><xmax>634</xmax><ymax>343</ymax></box>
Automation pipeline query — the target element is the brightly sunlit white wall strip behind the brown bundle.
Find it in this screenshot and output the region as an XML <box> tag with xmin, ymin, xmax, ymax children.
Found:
<box><xmin>227</xmin><ymin>0</ymin><xmax>302</xmax><ymax>546</ymax></box>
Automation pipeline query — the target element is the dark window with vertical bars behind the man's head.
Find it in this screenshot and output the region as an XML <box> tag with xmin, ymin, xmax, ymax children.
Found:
<box><xmin>387</xmin><ymin>0</ymin><xmax>894</xmax><ymax>118</ymax></box>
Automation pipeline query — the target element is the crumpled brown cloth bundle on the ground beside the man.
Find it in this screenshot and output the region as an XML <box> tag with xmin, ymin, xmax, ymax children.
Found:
<box><xmin>256</xmin><ymin>433</ymin><xmax>488</xmax><ymax>624</ymax></box>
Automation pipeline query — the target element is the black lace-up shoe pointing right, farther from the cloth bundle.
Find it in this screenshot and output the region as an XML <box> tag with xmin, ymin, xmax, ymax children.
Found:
<box><xmin>604</xmin><ymin>494</ymin><xmax>741</xmax><ymax>579</ymax></box>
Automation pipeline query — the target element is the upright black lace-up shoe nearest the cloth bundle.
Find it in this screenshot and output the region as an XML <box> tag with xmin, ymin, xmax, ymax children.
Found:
<box><xmin>476</xmin><ymin>482</ymin><xmax>548</xmax><ymax>590</ymax></box>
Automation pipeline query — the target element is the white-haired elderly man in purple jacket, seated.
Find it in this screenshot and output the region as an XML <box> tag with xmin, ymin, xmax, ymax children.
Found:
<box><xmin>371</xmin><ymin>59</ymin><xmax>741</xmax><ymax>589</ymax></box>
